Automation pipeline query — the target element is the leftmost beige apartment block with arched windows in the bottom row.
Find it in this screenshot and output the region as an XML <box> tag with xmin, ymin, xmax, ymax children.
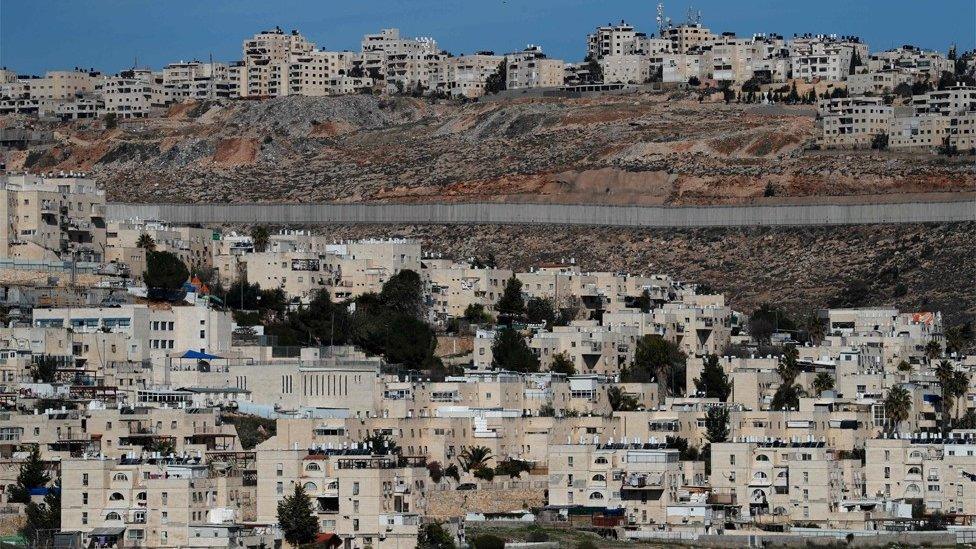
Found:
<box><xmin>61</xmin><ymin>455</ymin><xmax>264</xmax><ymax>547</ymax></box>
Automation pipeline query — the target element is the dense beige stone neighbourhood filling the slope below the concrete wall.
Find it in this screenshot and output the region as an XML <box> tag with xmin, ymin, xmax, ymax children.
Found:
<box><xmin>0</xmin><ymin>174</ymin><xmax>976</xmax><ymax>548</ymax></box>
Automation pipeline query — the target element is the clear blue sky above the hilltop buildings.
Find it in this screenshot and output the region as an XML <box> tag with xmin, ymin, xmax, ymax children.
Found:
<box><xmin>0</xmin><ymin>0</ymin><xmax>976</xmax><ymax>73</ymax></box>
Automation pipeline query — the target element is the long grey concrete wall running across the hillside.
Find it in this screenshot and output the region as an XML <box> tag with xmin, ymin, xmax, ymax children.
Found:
<box><xmin>108</xmin><ymin>199</ymin><xmax>976</xmax><ymax>227</ymax></box>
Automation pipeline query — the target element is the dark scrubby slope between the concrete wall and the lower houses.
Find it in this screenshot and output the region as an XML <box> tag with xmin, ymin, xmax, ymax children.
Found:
<box><xmin>304</xmin><ymin>221</ymin><xmax>976</xmax><ymax>324</ymax></box>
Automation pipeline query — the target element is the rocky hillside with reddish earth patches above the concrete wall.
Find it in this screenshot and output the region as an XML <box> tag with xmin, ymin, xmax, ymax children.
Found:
<box><xmin>0</xmin><ymin>94</ymin><xmax>976</xmax><ymax>204</ymax></box>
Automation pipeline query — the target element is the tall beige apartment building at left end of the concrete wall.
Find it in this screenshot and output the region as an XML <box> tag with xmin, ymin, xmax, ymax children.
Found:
<box><xmin>0</xmin><ymin>174</ymin><xmax>106</xmax><ymax>261</ymax></box>
